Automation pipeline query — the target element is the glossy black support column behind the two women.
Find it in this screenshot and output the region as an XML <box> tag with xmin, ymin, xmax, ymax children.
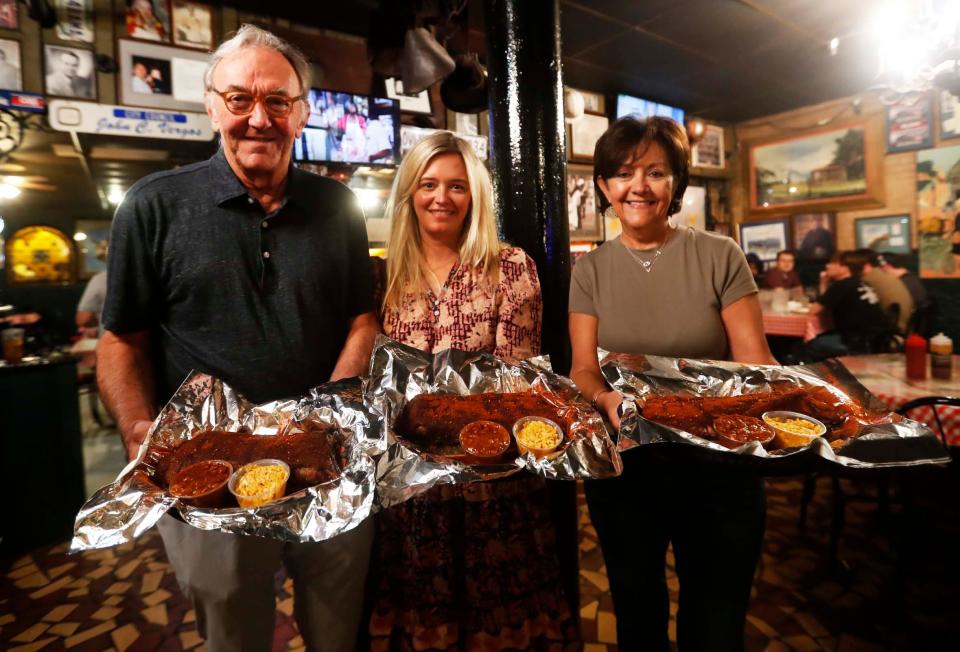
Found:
<box><xmin>486</xmin><ymin>0</ymin><xmax>580</xmax><ymax>622</ymax></box>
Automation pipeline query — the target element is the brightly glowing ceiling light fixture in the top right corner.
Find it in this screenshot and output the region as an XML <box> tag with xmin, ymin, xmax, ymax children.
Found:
<box><xmin>871</xmin><ymin>0</ymin><xmax>960</xmax><ymax>104</ymax></box>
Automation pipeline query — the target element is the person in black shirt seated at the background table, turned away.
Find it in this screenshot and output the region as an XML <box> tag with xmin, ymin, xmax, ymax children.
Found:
<box><xmin>804</xmin><ymin>251</ymin><xmax>892</xmax><ymax>361</ymax></box>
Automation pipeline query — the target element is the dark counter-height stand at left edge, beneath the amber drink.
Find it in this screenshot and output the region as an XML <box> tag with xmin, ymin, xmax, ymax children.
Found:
<box><xmin>0</xmin><ymin>354</ymin><xmax>85</xmax><ymax>557</ymax></box>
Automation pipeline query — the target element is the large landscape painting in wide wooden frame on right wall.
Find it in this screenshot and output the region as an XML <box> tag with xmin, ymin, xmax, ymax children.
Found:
<box><xmin>748</xmin><ymin>120</ymin><xmax>883</xmax><ymax>213</ymax></box>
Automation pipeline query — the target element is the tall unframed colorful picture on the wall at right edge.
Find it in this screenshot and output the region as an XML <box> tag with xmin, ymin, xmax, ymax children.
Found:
<box><xmin>917</xmin><ymin>145</ymin><xmax>960</xmax><ymax>278</ymax></box>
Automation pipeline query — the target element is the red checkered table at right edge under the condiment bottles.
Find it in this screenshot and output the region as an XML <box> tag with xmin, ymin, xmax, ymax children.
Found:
<box><xmin>839</xmin><ymin>353</ymin><xmax>960</xmax><ymax>446</ymax></box>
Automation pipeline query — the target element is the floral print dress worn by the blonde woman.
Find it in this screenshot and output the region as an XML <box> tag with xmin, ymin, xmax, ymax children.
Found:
<box><xmin>368</xmin><ymin>247</ymin><xmax>578</xmax><ymax>651</ymax></box>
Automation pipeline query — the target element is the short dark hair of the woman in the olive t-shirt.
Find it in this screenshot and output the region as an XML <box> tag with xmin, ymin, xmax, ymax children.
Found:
<box><xmin>593</xmin><ymin>116</ymin><xmax>690</xmax><ymax>215</ymax></box>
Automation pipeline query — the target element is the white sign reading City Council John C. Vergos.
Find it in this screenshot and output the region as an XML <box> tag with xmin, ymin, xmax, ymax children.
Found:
<box><xmin>49</xmin><ymin>100</ymin><xmax>213</xmax><ymax>140</ymax></box>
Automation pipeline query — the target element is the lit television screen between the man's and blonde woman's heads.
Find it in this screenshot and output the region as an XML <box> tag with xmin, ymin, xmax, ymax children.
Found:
<box><xmin>293</xmin><ymin>88</ymin><xmax>400</xmax><ymax>165</ymax></box>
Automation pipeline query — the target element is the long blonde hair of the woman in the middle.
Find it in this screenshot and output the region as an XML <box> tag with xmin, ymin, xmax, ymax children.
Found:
<box><xmin>383</xmin><ymin>131</ymin><xmax>502</xmax><ymax>308</ymax></box>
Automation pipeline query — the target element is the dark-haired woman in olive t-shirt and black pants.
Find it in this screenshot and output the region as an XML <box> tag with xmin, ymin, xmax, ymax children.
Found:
<box><xmin>570</xmin><ymin>118</ymin><xmax>776</xmax><ymax>651</ymax></box>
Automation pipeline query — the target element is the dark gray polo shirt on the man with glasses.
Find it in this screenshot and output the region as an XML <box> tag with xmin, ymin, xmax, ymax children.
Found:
<box><xmin>103</xmin><ymin>150</ymin><xmax>373</xmax><ymax>405</ymax></box>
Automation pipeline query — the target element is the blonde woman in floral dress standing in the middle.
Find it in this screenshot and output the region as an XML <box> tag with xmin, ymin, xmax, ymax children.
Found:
<box><xmin>369</xmin><ymin>132</ymin><xmax>577</xmax><ymax>650</ymax></box>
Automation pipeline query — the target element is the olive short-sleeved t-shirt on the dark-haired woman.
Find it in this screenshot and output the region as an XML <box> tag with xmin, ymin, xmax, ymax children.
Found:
<box><xmin>570</xmin><ymin>226</ymin><xmax>757</xmax><ymax>360</ymax></box>
